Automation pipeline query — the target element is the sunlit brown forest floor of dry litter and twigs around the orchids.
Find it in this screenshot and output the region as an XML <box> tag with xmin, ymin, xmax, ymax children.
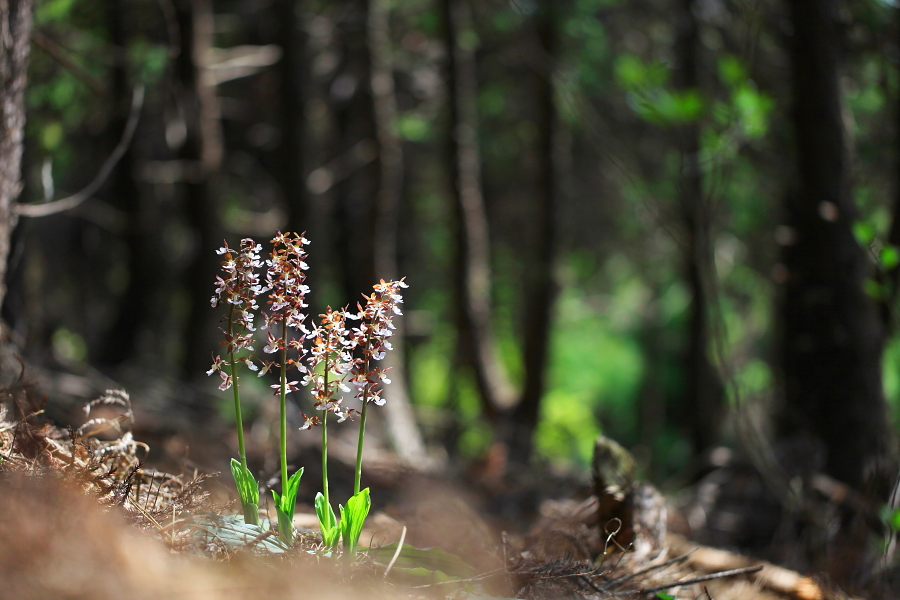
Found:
<box><xmin>0</xmin><ymin>370</ymin><xmax>890</xmax><ymax>600</ymax></box>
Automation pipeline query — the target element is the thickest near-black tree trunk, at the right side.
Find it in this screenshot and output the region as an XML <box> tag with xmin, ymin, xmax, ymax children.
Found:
<box><xmin>778</xmin><ymin>0</ymin><xmax>890</xmax><ymax>489</ymax></box>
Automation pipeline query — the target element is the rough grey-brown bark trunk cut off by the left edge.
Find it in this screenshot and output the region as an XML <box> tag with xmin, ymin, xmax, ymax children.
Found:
<box><xmin>0</xmin><ymin>0</ymin><xmax>32</xmax><ymax>316</ymax></box>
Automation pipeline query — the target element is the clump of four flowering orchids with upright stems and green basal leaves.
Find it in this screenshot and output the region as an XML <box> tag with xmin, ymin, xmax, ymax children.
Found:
<box><xmin>207</xmin><ymin>231</ymin><xmax>407</xmax><ymax>556</ymax></box>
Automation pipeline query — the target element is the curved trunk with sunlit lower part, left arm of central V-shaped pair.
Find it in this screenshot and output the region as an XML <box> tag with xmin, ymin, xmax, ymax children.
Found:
<box><xmin>441</xmin><ymin>0</ymin><xmax>515</xmax><ymax>420</ymax></box>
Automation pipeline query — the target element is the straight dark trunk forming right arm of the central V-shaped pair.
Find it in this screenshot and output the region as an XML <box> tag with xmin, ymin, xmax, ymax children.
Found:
<box><xmin>509</xmin><ymin>0</ymin><xmax>560</xmax><ymax>462</ymax></box>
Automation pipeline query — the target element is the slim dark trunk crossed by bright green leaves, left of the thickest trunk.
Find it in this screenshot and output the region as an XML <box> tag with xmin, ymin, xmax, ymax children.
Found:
<box><xmin>675</xmin><ymin>0</ymin><xmax>722</xmax><ymax>454</ymax></box>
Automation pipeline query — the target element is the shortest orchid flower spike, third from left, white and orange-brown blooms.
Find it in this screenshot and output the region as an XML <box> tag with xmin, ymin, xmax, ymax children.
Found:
<box><xmin>301</xmin><ymin>306</ymin><xmax>355</xmax><ymax>429</ymax></box>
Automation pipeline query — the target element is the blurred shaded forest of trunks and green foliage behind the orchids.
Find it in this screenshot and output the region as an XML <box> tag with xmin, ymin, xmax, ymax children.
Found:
<box><xmin>2</xmin><ymin>0</ymin><xmax>900</xmax><ymax>516</ymax></box>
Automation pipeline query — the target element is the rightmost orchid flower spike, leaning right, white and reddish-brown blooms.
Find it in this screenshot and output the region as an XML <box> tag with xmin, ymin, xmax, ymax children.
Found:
<box><xmin>348</xmin><ymin>279</ymin><xmax>408</xmax><ymax>406</ymax></box>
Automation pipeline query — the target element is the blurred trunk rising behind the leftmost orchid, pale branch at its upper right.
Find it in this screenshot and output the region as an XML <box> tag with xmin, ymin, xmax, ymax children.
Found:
<box><xmin>175</xmin><ymin>0</ymin><xmax>223</xmax><ymax>378</ymax></box>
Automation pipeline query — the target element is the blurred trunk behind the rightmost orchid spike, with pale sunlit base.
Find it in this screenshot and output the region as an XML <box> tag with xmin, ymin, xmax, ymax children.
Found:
<box><xmin>367</xmin><ymin>0</ymin><xmax>425</xmax><ymax>462</ymax></box>
